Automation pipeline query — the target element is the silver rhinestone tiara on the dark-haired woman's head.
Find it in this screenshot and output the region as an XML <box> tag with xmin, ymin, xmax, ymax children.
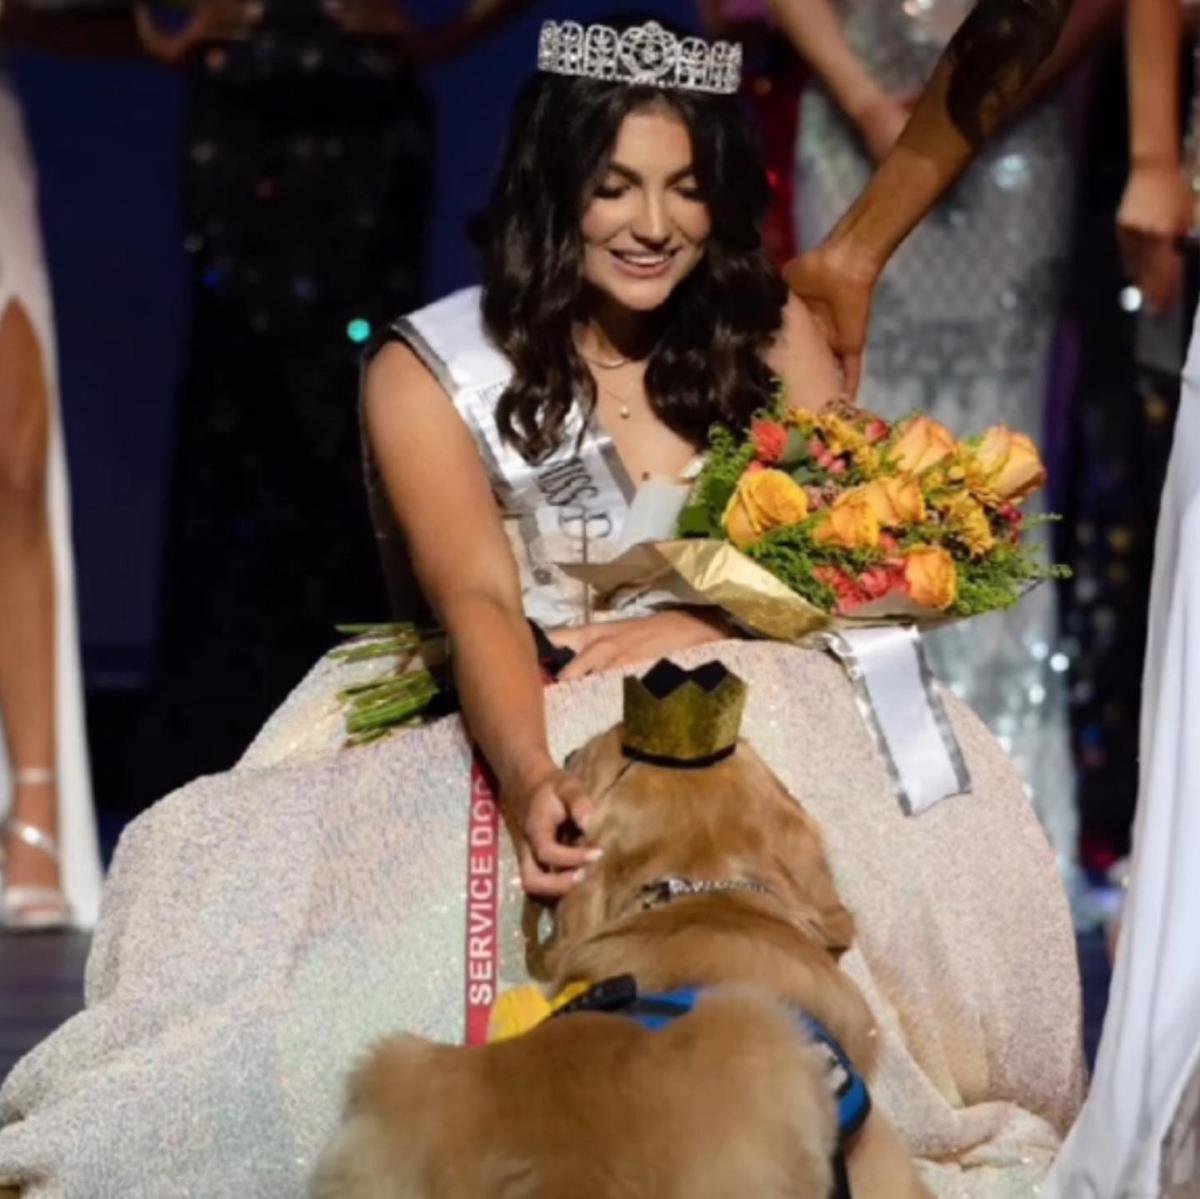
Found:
<box><xmin>538</xmin><ymin>20</ymin><xmax>742</xmax><ymax>95</ymax></box>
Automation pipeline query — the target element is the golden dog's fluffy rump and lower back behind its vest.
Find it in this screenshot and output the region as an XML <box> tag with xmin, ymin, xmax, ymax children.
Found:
<box><xmin>313</xmin><ymin>988</ymin><xmax>836</xmax><ymax>1199</ymax></box>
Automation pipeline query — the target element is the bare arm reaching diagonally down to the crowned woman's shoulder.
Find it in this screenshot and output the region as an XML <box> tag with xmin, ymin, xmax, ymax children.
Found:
<box><xmin>784</xmin><ymin>0</ymin><xmax>1073</xmax><ymax>396</ymax></box>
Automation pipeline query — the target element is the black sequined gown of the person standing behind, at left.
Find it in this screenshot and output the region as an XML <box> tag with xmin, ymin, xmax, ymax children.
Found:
<box><xmin>137</xmin><ymin>9</ymin><xmax>433</xmax><ymax>802</ymax></box>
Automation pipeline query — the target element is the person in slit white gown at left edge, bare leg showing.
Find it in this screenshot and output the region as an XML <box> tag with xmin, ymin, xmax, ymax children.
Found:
<box><xmin>0</xmin><ymin>32</ymin><xmax>101</xmax><ymax>929</ymax></box>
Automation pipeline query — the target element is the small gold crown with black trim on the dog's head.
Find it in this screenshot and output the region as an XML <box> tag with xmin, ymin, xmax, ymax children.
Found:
<box><xmin>620</xmin><ymin>658</ymin><xmax>746</xmax><ymax>768</ymax></box>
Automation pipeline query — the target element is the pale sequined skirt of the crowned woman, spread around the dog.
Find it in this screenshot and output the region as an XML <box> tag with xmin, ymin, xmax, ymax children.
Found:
<box><xmin>0</xmin><ymin>642</ymin><xmax>1081</xmax><ymax>1199</ymax></box>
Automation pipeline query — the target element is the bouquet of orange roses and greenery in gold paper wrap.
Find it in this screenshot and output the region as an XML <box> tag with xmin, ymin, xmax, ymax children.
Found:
<box><xmin>578</xmin><ymin>404</ymin><xmax>1068</xmax><ymax>639</ymax></box>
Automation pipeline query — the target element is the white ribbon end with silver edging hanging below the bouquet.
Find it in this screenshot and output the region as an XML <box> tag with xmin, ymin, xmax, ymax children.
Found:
<box><xmin>815</xmin><ymin>624</ymin><xmax>971</xmax><ymax>816</ymax></box>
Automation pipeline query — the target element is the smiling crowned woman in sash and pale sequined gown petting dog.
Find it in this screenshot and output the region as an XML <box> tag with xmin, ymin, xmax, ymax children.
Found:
<box><xmin>0</xmin><ymin>11</ymin><xmax>1082</xmax><ymax>1199</ymax></box>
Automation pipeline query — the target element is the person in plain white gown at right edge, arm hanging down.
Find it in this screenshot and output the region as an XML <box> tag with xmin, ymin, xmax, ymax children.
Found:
<box><xmin>1046</xmin><ymin>0</ymin><xmax>1200</xmax><ymax>1199</ymax></box>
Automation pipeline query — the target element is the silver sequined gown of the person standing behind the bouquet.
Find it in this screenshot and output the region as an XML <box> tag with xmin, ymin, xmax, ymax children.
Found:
<box><xmin>797</xmin><ymin>0</ymin><xmax>1078</xmax><ymax>883</ymax></box>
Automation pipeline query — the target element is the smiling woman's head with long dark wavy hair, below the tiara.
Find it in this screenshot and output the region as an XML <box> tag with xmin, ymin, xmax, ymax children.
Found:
<box><xmin>473</xmin><ymin>42</ymin><xmax>796</xmax><ymax>469</ymax></box>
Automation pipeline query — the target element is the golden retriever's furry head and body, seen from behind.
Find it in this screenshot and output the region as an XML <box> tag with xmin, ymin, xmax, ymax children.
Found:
<box><xmin>312</xmin><ymin>726</ymin><xmax>929</xmax><ymax>1199</ymax></box>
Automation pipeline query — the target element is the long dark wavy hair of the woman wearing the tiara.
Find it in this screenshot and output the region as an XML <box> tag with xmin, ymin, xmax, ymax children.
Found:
<box><xmin>472</xmin><ymin>22</ymin><xmax>787</xmax><ymax>461</ymax></box>
